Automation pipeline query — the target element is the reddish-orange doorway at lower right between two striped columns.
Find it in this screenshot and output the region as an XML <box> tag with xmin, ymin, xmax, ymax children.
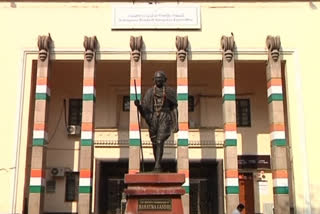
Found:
<box><xmin>239</xmin><ymin>173</ymin><xmax>254</xmax><ymax>214</ymax></box>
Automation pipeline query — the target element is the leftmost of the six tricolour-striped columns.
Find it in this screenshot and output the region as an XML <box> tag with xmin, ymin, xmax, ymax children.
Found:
<box><xmin>28</xmin><ymin>34</ymin><xmax>52</xmax><ymax>214</ymax></box>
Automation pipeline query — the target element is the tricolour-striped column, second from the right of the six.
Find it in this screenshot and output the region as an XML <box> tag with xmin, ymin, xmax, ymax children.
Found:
<box><xmin>221</xmin><ymin>35</ymin><xmax>239</xmax><ymax>213</ymax></box>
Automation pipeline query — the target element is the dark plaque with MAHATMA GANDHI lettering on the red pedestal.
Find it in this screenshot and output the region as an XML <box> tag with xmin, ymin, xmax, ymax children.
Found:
<box><xmin>138</xmin><ymin>198</ymin><xmax>172</xmax><ymax>211</ymax></box>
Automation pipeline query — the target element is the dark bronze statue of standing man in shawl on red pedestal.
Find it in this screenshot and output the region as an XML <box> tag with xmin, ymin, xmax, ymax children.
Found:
<box><xmin>134</xmin><ymin>71</ymin><xmax>178</xmax><ymax>172</ymax></box>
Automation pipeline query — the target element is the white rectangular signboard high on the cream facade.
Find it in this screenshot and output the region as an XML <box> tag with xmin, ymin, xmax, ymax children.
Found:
<box><xmin>112</xmin><ymin>4</ymin><xmax>201</xmax><ymax>29</ymax></box>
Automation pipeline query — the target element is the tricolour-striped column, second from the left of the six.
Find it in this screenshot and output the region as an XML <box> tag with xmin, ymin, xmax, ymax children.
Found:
<box><xmin>78</xmin><ymin>36</ymin><xmax>97</xmax><ymax>214</ymax></box>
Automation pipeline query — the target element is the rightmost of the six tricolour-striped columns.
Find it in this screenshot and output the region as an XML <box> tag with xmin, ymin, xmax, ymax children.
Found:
<box><xmin>266</xmin><ymin>36</ymin><xmax>290</xmax><ymax>214</ymax></box>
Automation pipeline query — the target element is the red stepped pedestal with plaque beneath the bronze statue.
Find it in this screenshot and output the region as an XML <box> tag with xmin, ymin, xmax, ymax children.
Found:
<box><xmin>125</xmin><ymin>173</ymin><xmax>185</xmax><ymax>214</ymax></box>
